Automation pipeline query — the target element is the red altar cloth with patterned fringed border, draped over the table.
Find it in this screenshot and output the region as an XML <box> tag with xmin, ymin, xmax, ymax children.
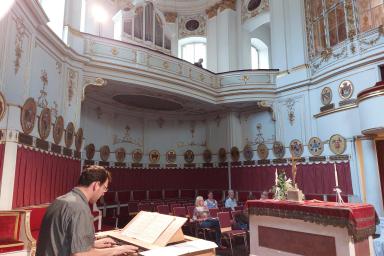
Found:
<box><xmin>246</xmin><ymin>200</ymin><xmax>379</xmax><ymax>241</ymax></box>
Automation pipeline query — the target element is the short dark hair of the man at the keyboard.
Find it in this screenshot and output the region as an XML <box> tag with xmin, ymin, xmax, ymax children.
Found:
<box><xmin>78</xmin><ymin>165</ymin><xmax>112</xmax><ymax>187</ymax></box>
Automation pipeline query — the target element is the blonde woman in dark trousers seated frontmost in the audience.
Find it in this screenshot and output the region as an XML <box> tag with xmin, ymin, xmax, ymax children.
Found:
<box><xmin>192</xmin><ymin>196</ymin><xmax>225</xmax><ymax>249</ymax></box>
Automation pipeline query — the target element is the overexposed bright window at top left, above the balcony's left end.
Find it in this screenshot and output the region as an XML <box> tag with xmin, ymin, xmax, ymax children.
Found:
<box><xmin>40</xmin><ymin>0</ymin><xmax>65</xmax><ymax>38</ymax></box>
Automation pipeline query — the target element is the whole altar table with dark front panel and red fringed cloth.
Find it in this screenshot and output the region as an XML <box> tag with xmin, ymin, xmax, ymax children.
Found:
<box><xmin>246</xmin><ymin>200</ymin><xmax>378</xmax><ymax>256</ymax></box>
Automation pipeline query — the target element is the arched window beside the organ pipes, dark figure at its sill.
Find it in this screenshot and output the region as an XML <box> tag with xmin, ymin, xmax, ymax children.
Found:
<box><xmin>179</xmin><ymin>37</ymin><xmax>207</xmax><ymax>68</ymax></box>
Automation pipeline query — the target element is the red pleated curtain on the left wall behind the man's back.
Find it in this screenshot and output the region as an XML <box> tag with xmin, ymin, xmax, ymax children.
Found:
<box><xmin>13</xmin><ymin>146</ymin><xmax>80</xmax><ymax>208</ymax></box>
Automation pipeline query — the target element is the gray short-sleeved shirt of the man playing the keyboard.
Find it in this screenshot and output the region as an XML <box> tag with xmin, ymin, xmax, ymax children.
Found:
<box><xmin>36</xmin><ymin>188</ymin><xmax>95</xmax><ymax>256</ymax></box>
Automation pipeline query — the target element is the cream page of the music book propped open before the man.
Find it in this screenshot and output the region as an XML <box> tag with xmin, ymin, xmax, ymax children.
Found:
<box><xmin>121</xmin><ymin>211</ymin><xmax>175</xmax><ymax>244</ymax></box>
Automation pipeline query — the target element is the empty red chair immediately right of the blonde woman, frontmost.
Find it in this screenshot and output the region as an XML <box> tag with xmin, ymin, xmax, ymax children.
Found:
<box><xmin>217</xmin><ymin>212</ymin><xmax>248</xmax><ymax>255</ymax></box>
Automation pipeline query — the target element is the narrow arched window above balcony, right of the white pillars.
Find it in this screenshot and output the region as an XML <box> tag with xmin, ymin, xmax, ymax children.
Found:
<box><xmin>251</xmin><ymin>38</ymin><xmax>269</xmax><ymax>69</ymax></box>
